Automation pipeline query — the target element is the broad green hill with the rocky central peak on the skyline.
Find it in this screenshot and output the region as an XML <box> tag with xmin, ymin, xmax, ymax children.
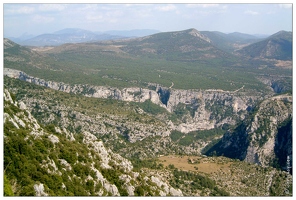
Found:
<box><xmin>113</xmin><ymin>29</ymin><xmax>236</xmax><ymax>61</ymax></box>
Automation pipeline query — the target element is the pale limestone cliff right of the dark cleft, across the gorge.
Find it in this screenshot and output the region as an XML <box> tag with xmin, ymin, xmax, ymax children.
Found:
<box><xmin>167</xmin><ymin>89</ymin><xmax>254</xmax><ymax>133</ymax></box>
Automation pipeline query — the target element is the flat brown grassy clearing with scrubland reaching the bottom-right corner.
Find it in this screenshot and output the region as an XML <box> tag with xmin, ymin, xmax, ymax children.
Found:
<box><xmin>158</xmin><ymin>155</ymin><xmax>292</xmax><ymax>196</ymax></box>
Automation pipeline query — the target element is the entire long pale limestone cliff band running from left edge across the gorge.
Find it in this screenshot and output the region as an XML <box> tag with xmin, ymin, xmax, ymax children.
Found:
<box><xmin>4</xmin><ymin>68</ymin><xmax>263</xmax><ymax>133</ymax></box>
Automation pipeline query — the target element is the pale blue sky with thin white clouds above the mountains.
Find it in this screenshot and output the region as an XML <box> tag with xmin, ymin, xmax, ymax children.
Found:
<box><xmin>3</xmin><ymin>2</ymin><xmax>292</xmax><ymax>37</ymax></box>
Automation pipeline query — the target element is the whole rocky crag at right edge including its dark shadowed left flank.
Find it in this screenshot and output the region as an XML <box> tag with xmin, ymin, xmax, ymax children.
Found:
<box><xmin>208</xmin><ymin>94</ymin><xmax>293</xmax><ymax>169</ymax></box>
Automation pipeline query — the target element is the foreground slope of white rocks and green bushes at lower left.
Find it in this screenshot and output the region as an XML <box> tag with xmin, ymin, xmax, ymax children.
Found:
<box><xmin>4</xmin><ymin>89</ymin><xmax>182</xmax><ymax>196</ymax></box>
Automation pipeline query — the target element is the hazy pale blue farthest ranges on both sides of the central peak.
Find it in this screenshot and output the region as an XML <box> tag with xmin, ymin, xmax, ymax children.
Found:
<box><xmin>8</xmin><ymin>28</ymin><xmax>267</xmax><ymax>50</ymax></box>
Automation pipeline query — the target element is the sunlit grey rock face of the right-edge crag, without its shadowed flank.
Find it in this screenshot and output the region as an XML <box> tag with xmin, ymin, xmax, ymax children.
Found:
<box><xmin>244</xmin><ymin>95</ymin><xmax>292</xmax><ymax>166</ymax></box>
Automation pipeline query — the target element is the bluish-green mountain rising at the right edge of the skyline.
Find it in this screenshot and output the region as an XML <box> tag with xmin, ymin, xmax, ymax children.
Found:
<box><xmin>238</xmin><ymin>31</ymin><xmax>292</xmax><ymax>60</ymax></box>
